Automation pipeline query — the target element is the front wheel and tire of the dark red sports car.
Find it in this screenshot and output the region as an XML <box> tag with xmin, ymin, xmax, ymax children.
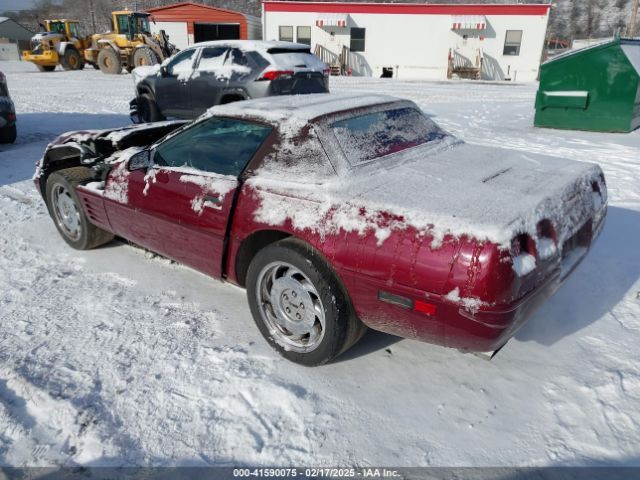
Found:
<box><xmin>45</xmin><ymin>167</ymin><xmax>113</xmax><ymax>250</ymax></box>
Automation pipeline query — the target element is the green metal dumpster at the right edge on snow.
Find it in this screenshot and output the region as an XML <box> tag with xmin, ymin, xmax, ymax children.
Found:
<box><xmin>535</xmin><ymin>38</ymin><xmax>640</xmax><ymax>132</ymax></box>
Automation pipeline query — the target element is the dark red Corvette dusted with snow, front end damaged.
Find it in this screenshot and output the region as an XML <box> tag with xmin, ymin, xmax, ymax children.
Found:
<box><xmin>35</xmin><ymin>95</ymin><xmax>607</xmax><ymax>365</ymax></box>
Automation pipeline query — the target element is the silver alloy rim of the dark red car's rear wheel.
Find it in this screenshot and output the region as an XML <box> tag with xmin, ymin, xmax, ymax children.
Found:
<box><xmin>256</xmin><ymin>261</ymin><xmax>325</xmax><ymax>353</ymax></box>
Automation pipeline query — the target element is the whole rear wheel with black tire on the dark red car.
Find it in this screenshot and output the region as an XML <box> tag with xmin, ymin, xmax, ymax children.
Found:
<box><xmin>246</xmin><ymin>239</ymin><xmax>366</xmax><ymax>366</ymax></box>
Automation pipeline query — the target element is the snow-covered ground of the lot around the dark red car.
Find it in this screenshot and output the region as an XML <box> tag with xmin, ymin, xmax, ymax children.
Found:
<box><xmin>0</xmin><ymin>62</ymin><xmax>640</xmax><ymax>466</ymax></box>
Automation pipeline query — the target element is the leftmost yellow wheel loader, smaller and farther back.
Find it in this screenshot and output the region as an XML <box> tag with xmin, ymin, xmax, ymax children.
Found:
<box><xmin>22</xmin><ymin>20</ymin><xmax>90</xmax><ymax>72</ymax></box>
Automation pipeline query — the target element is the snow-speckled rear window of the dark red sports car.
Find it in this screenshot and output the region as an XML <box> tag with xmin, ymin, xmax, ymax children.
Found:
<box><xmin>331</xmin><ymin>107</ymin><xmax>447</xmax><ymax>166</ymax></box>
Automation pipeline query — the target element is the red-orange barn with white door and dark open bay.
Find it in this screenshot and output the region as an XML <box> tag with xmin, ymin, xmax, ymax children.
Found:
<box><xmin>147</xmin><ymin>2</ymin><xmax>262</xmax><ymax>49</ymax></box>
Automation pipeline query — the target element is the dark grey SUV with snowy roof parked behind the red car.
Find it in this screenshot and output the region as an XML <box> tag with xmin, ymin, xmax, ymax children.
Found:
<box><xmin>130</xmin><ymin>40</ymin><xmax>330</xmax><ymax>123</ymax></box>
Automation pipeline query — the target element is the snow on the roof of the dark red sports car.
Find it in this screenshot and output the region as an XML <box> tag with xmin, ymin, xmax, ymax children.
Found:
<box><xmin>208</xmin><ymin>93</ymin><xmax>406</xmax><ymax>123</ymax></box>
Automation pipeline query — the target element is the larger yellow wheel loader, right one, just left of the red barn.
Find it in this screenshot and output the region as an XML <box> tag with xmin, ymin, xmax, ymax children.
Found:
<box><xmin>84</xmin><ymin>10</ymin><xmax>175</xmax><ymax>75</ymax></box>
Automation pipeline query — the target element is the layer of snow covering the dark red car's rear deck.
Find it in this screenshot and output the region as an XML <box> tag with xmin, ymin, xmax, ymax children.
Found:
<box><xmin>254</xmin><ymin>141</ymin><xmax>606</xmax><ymax>248</ymax></box>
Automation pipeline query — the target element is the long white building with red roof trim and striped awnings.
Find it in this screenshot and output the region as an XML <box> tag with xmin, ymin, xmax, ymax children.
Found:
<box><xmin>262</xmin><ymin>0</ymin><xmax>551</xmax><ymax>81</ymax></box>
